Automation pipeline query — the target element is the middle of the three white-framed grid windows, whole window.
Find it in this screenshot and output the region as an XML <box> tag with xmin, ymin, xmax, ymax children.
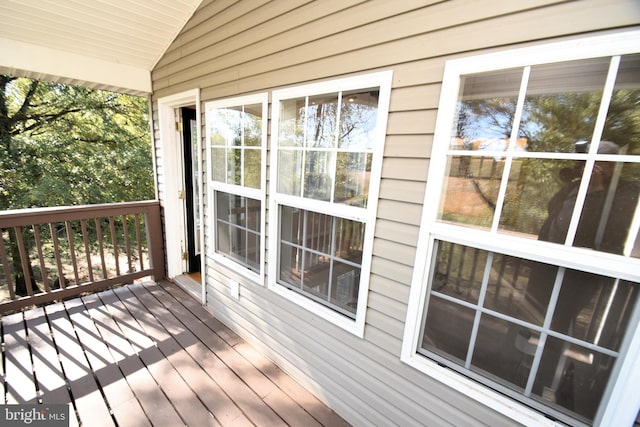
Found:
<box><xmin>269</xmin><ymin>72</ymin><xmax>391</xmax><ymax>335</ymax></box>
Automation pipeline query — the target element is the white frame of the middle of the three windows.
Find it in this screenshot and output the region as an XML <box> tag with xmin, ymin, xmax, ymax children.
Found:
<box><xmin>268</xmin><ymin>71</ymin><xmax>393</xmax><ymax>337</ymax></box>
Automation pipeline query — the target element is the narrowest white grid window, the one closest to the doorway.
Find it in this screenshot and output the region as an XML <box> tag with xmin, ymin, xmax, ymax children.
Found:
<box><xmin>205</xmin><ymin>94</ymin><xmax>268</xmax><ymax>283</ymax></box>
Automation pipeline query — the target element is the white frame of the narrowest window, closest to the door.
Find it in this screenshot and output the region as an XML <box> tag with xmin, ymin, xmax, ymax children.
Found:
<box><xmin>205</xmin><ymin>92</ymin><xmax>269</xmax><ymax>286</ymax></box>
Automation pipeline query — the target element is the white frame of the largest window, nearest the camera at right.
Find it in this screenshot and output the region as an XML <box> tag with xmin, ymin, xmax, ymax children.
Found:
<box><xmin>401</xmin><ymin>31</ymin><xmax>640</xmax><ymax>426</ymax></box>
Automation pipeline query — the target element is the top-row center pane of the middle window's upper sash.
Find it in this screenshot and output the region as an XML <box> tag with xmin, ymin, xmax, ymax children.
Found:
<box><xmin>306</xmin><ymin>93</ymin><xmax>338</xmax><ymax>148</ymax></box>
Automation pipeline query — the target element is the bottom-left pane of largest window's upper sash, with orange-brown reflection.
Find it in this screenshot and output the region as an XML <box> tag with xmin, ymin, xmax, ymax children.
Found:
<box><xmin>439</xmin><ymin>156</ymin><xmax>504</xmax><ymax>228</ymax></box>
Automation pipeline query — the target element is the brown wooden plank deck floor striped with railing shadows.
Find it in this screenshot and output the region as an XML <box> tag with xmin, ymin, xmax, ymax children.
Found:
<box><xmin>0</xmin><ymin>281</ymin><xmax>347</xmax><ymax>427</ymax></box>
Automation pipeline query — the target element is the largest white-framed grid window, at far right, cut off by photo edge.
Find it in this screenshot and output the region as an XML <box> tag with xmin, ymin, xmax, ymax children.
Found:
<box><xmin>402</xmin><ymin>34</ymin><xmax>640</xmax><ymax>425</ymax></box>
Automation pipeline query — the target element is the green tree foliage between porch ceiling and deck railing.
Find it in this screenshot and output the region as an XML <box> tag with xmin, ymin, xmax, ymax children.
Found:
<box><xmin>0</xmin><ymin>75</ymin><xmax>153</xmax><ymax>210</ymax></box>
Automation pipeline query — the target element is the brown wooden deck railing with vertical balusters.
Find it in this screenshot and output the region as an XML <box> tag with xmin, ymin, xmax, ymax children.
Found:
<box><xmin>0</xmin><ymin>201</ymin><xmax>165</xmax><ymax>314</ymax></box>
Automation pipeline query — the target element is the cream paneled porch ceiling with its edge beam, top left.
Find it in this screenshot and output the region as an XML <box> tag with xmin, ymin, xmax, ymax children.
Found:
<box><xmin>0</xmin><ymin>0</ymin><xmax>202</xmax><ymax>94</ymax></box>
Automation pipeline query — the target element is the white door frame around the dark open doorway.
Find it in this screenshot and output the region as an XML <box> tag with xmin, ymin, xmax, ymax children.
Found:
<box><xmin>156</xmin><ymin>89</ymin><xmax>206</xmax><ymax>304</ymax></box>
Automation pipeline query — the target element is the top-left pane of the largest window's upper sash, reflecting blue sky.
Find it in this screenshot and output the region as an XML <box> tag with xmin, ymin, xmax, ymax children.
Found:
<box><xmin>451</xmin><ymin>70</ymin><xmax>522</xmax><ymax>150</ymax></box>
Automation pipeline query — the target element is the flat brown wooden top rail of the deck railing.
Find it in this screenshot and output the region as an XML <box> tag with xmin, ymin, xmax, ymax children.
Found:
<box><xmin>0</xmin><ymin>200</ymin><xmax>160</xmax><ymax>228</ymax></box>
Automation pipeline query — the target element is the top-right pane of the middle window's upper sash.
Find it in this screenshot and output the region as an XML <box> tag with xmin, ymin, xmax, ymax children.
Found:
<box><xmin>338</xmin><ymin>89</ymin><xmax>380</xmax><ymax>150</ymax></box>
